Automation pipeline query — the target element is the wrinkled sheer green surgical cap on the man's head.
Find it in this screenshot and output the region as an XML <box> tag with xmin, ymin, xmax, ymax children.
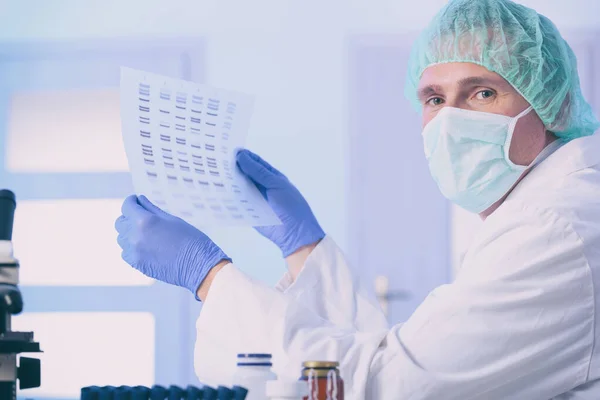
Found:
<box><xmin>405</xmin><ymin>0</ymin><xmax>600</xmax><ymax>139</ymax></box>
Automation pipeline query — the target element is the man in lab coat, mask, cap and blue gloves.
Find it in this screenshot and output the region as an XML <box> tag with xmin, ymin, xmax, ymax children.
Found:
<box><xmin>117</xmin><ymin>0</ymin><xmax>600</xmax><ymax>400</ymax></box>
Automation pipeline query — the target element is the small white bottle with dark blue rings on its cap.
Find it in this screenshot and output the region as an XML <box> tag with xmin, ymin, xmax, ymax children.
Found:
<box><xmin>233</xmin><ymin>354</ymin><xmax>277</xmax><ymax>400</ymax></box>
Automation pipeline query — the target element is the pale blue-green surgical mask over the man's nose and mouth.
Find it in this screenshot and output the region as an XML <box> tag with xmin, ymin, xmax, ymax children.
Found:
<box><xmin>423</xmin><ymin>107</ymin><xmax>533</xmax><ymax>213</ymax></box>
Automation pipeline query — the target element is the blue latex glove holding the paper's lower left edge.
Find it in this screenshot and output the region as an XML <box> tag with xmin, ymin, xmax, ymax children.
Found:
<box><xmin>115</xmin><ymin>196</ymin><xmax>231</xmax><ymax>295</ymax></box>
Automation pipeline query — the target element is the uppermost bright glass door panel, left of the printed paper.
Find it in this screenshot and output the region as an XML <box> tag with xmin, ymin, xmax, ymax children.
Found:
<box><xmin>6</xmin><ymin>88</ymin><xmax>128</xmax><ymax>172</ymax></box>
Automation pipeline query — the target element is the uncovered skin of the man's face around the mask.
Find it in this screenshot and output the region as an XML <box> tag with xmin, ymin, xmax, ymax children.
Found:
<box><xmin>418</xmin><ymin>63</ymin><xmax>546</xmax><ymax>165</ymax></box>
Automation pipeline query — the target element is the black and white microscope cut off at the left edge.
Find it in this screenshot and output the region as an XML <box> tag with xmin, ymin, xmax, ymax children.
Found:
<box><xmin>0</xmin><ymin>189</ymin><xmax>41</xmax><ymax>400</ymax></box>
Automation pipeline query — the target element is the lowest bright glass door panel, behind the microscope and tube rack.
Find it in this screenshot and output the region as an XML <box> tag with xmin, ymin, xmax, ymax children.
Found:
<box><xmin>12</xmin><ymin>312</ymin><xmax>155</xmax><ymax>398</ymax></box>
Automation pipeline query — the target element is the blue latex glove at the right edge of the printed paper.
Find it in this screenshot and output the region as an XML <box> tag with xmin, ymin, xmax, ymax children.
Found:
<box><xmin>237</xmin><ymin>150</ymin><xmax>325</xmax><ymax>257</ymax></box>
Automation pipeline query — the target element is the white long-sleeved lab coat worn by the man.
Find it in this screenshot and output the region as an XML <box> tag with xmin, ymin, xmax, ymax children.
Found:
<box><xmin>195</xmin><ymin>134</ymin><xmax>600</xmax><ymax>400</ymax></box>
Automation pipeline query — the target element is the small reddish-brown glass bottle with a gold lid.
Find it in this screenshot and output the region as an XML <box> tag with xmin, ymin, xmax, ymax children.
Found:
<box><xmin>300</xmin><ymin>361</ymin><xmax>344</xmax><ymax>400</ymax></box>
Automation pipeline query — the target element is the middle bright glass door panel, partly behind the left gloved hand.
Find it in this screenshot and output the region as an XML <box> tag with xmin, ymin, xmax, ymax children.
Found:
<box><xmin>13</xmin><ymin>199</ymin><xmax>153</xmax><ymax>286</ymax></box>
